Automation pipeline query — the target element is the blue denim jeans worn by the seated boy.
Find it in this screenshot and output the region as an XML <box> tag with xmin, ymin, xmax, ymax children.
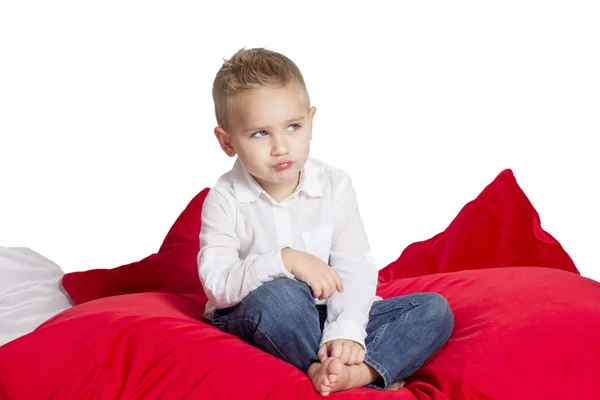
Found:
<box><xmin>212</xmin><ymin>278</ymin><xmax>454</xmax><ymax>388</ymax></box>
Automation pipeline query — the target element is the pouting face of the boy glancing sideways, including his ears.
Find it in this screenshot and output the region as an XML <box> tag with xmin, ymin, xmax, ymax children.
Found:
<box><xmin>215</xmin><ymin>84</ymin><xmax>316</xmax><ymax>196</ymax></box>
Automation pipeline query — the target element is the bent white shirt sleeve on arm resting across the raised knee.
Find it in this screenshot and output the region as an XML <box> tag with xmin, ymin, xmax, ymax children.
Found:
<box><xmin>198</xmin><ymin>189</ymin><xmax>293</xmax><ymax>308</ymax></box>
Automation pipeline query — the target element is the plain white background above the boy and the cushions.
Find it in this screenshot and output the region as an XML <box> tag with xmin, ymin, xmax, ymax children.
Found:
<box><xmin>0</xmin><ymin>0</ymin><xmax>600</xmax><ymax>280</ymax></box>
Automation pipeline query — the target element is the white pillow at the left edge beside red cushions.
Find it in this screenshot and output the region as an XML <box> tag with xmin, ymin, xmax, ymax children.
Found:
<box><xmin>0</xmin><ymin>246</ymin><xmax>73</xmax><ymax>346</ymax></box>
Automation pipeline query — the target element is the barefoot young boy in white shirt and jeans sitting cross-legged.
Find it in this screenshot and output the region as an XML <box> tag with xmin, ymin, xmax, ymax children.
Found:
<box><xmin>198</xmin><ymin>49</ymin><xmax>454</xmax><ymax>396</ymax></box>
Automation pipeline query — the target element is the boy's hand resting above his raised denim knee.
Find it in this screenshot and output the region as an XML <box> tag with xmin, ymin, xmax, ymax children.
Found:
<box><xmin>281</xmin><ymin>248</ymin><xmax>344</xmax><ymax>300</ymax></box>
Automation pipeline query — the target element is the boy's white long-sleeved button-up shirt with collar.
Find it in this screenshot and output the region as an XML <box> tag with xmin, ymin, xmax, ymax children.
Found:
<box><xmin>198</xmin><ymin>158</ymin><xmax>380</xmax><ymax>349</ymax></box>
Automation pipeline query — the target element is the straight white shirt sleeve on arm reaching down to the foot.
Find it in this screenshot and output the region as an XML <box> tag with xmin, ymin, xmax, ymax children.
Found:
<box><xmin>321</xmin><ymin>178</ymin><xmax>377</xmax><ymax>349</ymax></box>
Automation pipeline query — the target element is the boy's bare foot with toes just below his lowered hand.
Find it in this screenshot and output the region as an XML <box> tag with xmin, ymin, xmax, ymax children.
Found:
<box><xmin>307</xmin><ymin>357</ymin><xmax>380</xmax><ymax>396</ymax></box>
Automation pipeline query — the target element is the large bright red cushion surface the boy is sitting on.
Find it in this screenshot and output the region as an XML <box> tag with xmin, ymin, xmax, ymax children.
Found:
<box><xmin>0</xmin><ymin>267</ymin><xmax>600</xmax><ymax>400</ymax></box>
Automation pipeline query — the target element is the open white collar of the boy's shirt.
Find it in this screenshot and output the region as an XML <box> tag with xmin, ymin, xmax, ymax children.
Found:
<box><xmin>233</xmin><ymin>158</ymin><xmax>323</xmax><ymax>203</ymax></box>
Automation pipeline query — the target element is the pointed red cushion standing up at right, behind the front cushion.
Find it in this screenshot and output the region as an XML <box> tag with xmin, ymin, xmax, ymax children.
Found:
<box><xmin>379</xmin><ymin>169</ymin><xmax>579</xmax><ymax>282</ymax></box>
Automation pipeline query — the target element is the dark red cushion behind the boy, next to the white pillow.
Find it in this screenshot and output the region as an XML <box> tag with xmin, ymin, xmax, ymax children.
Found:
<box><xmin>62</xmin><ymin>188</ymin><xmax>209</xmax><ymax>304</ymax></box>
